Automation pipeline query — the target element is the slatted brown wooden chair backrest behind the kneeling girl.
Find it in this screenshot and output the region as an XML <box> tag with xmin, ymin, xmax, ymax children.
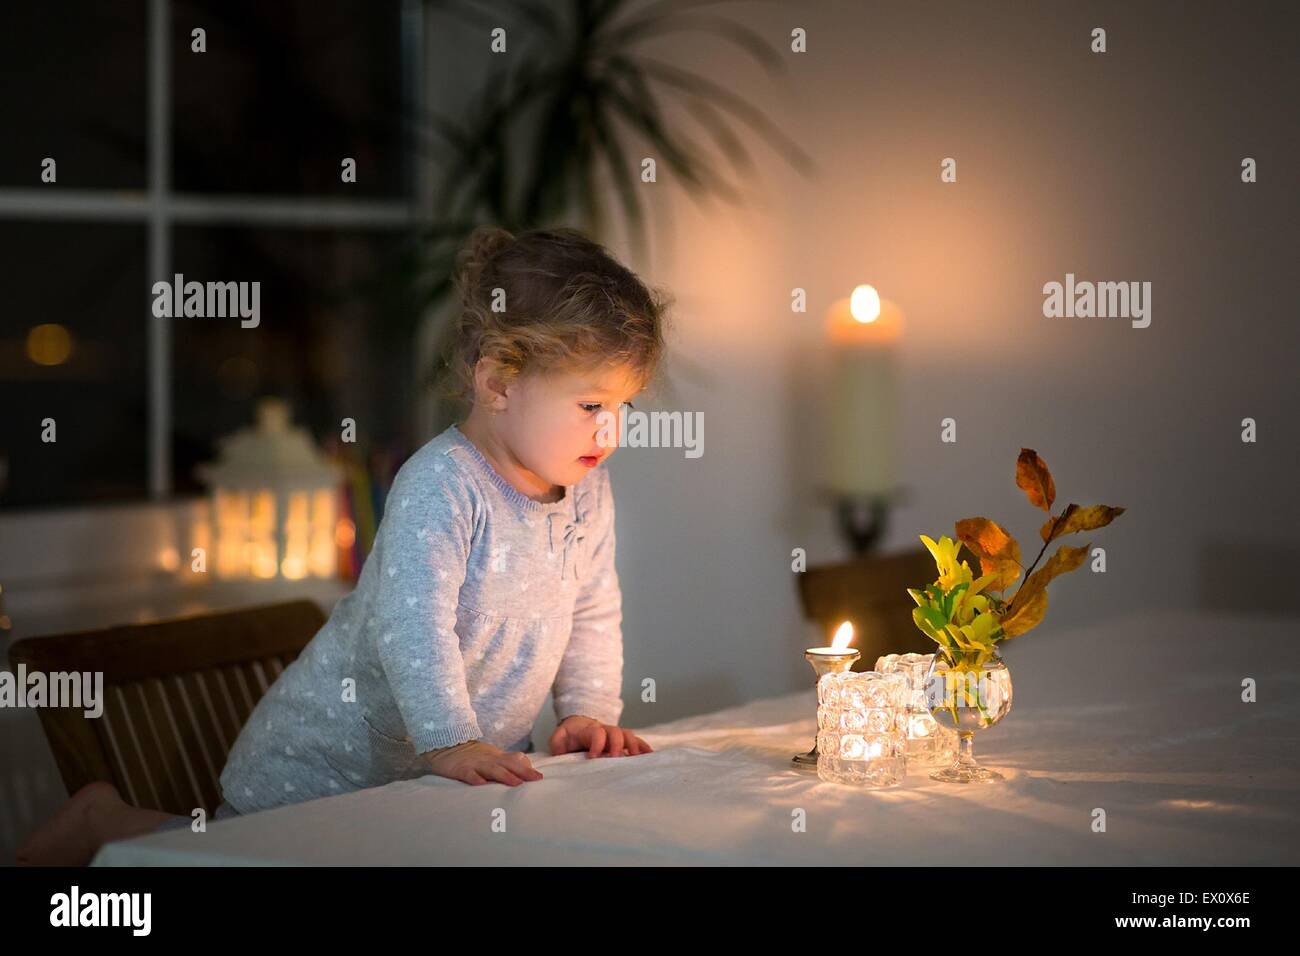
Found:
<box><xmin>9</xmin><ymin>600</ymin><xmax>325</xmax><ymax>816</ymax></box>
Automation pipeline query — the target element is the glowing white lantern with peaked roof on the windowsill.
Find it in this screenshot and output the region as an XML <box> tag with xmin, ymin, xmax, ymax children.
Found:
<box><xmin>195</xmin><ymin>398</ymin><xmax>342</xmax><ymax>580</ymax></box>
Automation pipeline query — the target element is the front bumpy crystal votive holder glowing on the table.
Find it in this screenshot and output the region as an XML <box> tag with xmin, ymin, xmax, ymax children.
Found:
<box><xmin>816</xmin><ymin>671</ymin><xmax>909</xmax><ymax>787</ymax></box>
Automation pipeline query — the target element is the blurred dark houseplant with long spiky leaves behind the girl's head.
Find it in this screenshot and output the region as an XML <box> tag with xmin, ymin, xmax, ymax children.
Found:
<box><xmin>384</xmin><ymin>0</ymin><xmax>815</xmax><ymax>432</ymax></box>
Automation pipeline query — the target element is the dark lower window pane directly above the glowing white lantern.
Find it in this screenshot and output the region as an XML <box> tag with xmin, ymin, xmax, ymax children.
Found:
<box><xmin>173</xmin><ymin>228</ymin><xmax>413</xmax><ymax>493</ymax></box>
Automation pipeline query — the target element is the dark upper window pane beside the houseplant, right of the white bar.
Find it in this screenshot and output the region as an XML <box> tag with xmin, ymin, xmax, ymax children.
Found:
<box><xmin>172</xmin><ymin>0</ymin><xmax>403</xmax><ymax>199</ymax></box>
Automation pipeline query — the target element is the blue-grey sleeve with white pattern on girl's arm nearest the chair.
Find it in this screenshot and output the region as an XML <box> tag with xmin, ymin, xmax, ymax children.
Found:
<box><xmin>365</xmin><ymin>455</ymin><xmax>482</xmax><ymax>753</ymax></box>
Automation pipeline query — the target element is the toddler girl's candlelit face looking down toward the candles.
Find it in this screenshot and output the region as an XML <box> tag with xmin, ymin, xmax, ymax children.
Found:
<box><xmin>467</xmin><ymin>365</ymin><xmax>641</xmax><ymax>496</ymax></box>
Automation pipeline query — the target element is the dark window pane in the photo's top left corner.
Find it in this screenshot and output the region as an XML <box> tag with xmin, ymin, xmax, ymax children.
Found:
<box><xmin>0</xmin><ymin>0</ymin><xmax>148</xmax><ymax>189</ymax></box>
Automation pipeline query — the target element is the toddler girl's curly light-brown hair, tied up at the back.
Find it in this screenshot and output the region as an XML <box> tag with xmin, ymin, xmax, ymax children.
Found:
<box><xmin>443</xmin><ymin>226</ymin><xmax>672</xmax><ymax>405</ymax></box>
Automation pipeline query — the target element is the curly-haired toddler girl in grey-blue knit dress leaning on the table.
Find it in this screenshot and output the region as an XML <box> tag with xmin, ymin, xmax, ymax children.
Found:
<box><xmin>20</xmin><ymin>226</ymin><xmax>667</xmax><ymax>864</ymax></box>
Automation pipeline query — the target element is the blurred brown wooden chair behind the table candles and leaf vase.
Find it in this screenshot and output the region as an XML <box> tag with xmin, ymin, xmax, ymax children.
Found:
<box><xmin>796</xmin><ymin>546</ymin><xmax>979</xmax><ymax>671</ymax></box>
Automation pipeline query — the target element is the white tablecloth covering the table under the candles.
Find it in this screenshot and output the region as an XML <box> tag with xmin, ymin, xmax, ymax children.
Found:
<box><xmin>95</xmin><ymin>611</ymin><xmax>1300</xmax><ymax>865</ymax></box>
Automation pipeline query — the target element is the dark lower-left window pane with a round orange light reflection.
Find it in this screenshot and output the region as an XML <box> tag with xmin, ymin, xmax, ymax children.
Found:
<box><xmin>0</xmin><ymin>221</ymin><xmax>150</xmax><ymax>507</ymax></box>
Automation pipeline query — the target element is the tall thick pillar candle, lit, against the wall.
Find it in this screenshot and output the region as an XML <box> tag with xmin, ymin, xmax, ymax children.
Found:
<box><xmin>826</xmin><ymin>285</ymin><xmax>902</xmax><ymax>496</ymax></box>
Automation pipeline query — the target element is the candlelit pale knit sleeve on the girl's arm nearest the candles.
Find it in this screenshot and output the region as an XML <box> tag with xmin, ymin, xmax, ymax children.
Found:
<box><xmin>551</xmin><ymin>468</ymin><xmax>623</xmax><ymax>724</ymax></box>
